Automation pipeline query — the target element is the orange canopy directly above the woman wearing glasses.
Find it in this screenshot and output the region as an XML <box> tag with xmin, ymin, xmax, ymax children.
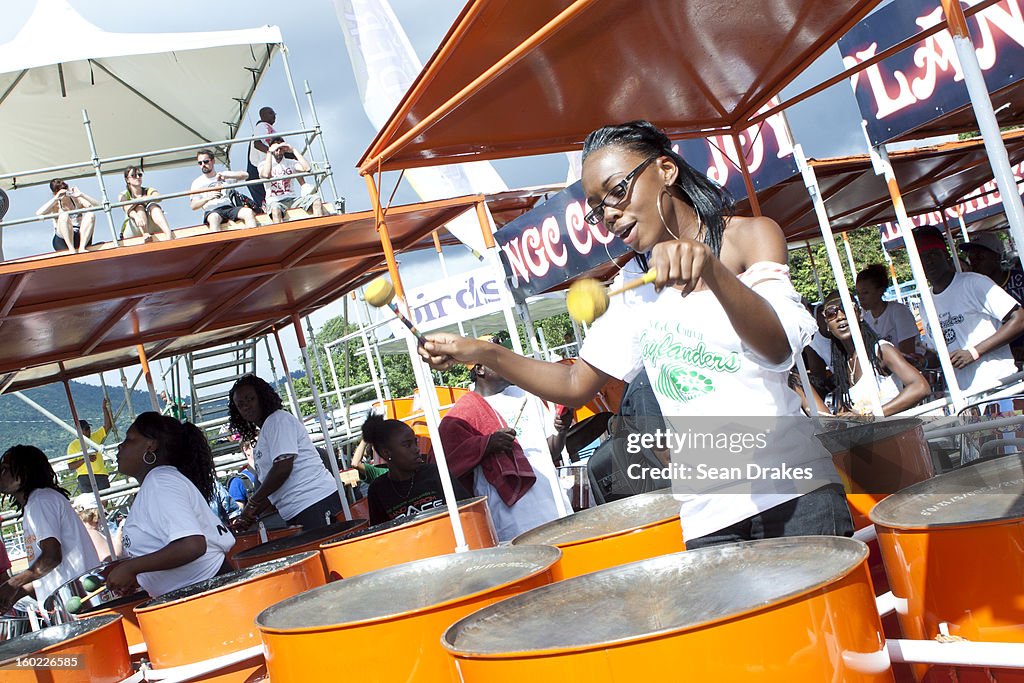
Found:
<box><xmin>358</xmin><ymin>0</ymin><xmax>879</xmax><ymax>173</ymax></box>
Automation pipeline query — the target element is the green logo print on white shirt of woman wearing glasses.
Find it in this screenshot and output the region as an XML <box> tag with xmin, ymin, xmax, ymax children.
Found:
<box><xmin>640</xmin><ymin>323</ymin><xmax>740</xmax><ymax>403</ymax></box>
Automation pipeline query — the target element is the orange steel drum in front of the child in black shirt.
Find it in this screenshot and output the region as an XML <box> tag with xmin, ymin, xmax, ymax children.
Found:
<box><xmin>319</xmin><ymin>497</ymin><xmax>498</xmax><ymax>581</ymax></box>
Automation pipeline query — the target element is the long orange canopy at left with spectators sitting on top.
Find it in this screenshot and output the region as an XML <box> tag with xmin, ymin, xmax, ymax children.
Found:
<box><xmin>0</xmin><ymin>189</ymin><xmax>547</xmax><ymax>391</ymax></box>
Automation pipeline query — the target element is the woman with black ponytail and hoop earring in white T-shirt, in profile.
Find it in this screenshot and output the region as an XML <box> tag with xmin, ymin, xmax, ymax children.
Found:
<box><xmin>106</xmin><ymin>412</ymin><xmax>234</xmax><ymax>597</ymax></box>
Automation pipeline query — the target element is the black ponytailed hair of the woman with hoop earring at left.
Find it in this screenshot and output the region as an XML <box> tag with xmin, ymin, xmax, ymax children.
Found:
<box><xmin>132</xmin><ymin>411</ymin><xmax>216</xmax><ymax>501</ymax></box>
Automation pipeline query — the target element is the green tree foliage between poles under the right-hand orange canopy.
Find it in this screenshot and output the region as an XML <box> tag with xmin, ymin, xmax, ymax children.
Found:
<box><xmin>790</xmin><ymin>225</ymin><xmax>913</xmax><ymax>301</ymax></box>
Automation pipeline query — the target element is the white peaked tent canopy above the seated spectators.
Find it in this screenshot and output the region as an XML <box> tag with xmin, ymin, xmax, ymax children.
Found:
<box><xmin>0</xmin><ymin>0</ymin><xmax>282</xmax><ymax>187</ymax></box>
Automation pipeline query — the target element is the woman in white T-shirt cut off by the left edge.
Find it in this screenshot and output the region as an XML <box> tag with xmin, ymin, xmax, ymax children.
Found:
<box><xmin>0</xmin><ymin>445</ymin><xmax>99</xmax><ymax>613</ymax></box>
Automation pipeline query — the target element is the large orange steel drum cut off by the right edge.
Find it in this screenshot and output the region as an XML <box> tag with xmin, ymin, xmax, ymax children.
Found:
<box><xmin>871</xmin><ymin>454</ymin><xmax>1024</xmax><ymax>681</ymax></box>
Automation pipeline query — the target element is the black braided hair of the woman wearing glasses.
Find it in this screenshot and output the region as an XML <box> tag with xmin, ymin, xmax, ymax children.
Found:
<box><xmin>583</xmin><ymin>121</ymin><xmax>735</xmax><ymax>258</ymax></box>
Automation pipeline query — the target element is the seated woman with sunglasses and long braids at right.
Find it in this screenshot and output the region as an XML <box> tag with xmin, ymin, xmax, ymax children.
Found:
<box><xmin>821</xmin><ymin>292</ymin><xmax>932</xmax><ymax>417</ymax></box>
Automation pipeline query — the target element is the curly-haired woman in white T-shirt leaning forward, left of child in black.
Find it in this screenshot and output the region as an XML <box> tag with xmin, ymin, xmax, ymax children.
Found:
<box><xmin>228</xmin><ymin>375</ymin><xmax>341</xmax><ymax>529</ymax></box>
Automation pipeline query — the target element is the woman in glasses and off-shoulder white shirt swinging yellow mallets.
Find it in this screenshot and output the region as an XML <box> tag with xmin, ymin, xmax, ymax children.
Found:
<box><xmin>421</xmin><ymin>121</ymin><xmax>852</xmax><ymax>548</ymax></box>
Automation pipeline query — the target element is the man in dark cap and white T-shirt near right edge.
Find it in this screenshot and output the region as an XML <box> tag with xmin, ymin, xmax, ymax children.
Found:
<box><xmin>913</xmin><ymin>225</ymin><xmax>1024</xmax><ymax>394</ymax></box>
